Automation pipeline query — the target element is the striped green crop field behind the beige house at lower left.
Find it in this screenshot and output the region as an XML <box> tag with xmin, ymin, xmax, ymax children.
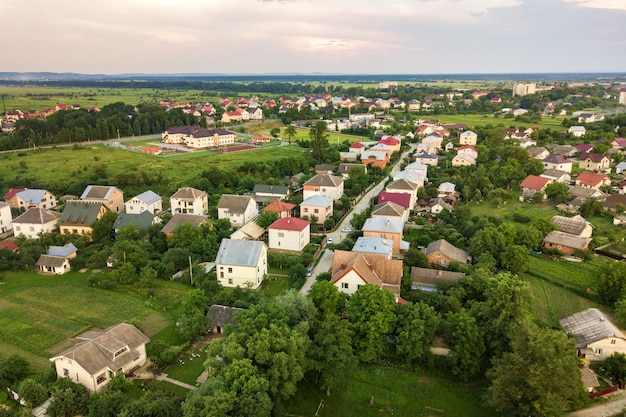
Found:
<box><xmin>0</xmin><ymin>272</ymin><xmax>184</xmax><ymax>372</ymax></box>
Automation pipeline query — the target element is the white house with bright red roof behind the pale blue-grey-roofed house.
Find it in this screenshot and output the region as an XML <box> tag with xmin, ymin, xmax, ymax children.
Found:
<box><xmin>267</xmin><ymin>217</ymin><xmax>311</xmax><ymax>253</ymax></box>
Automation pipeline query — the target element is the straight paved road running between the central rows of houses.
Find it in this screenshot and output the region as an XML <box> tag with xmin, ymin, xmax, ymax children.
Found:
<box><xmin>300</xmin><ymin>145</ymin><xmax>415</xmax><ymax>294</ymax></box>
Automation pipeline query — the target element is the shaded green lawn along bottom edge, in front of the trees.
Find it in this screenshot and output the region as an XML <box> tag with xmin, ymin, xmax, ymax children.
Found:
<box><xmin>286</xmin><ymin>365</ymin><xmax>497</xmax><ymax>417</ymax></box>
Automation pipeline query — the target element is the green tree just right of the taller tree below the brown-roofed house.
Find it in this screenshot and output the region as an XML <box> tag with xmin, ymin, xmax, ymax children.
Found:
<box><xmin>396</xmin><ymin>302</ymin><xmax>440</xmax><ymax>362</ymax></box>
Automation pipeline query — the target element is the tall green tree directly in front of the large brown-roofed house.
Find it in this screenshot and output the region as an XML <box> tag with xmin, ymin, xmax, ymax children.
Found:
<box><xmin>347</xmin><ymin>284</ymin><xmax>396</xmax><ymax>362</ymax></box>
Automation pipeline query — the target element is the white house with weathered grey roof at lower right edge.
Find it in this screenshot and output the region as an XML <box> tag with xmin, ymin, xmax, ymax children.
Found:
<box><xmin>559</xmin><ymin>308</ymin><xmax>626</xmax><ymax>362</ymax></box>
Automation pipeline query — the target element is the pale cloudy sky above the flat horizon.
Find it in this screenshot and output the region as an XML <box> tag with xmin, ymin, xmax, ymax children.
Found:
<box><xmin>0</xmin><ymin>0</ymin><xmax>626</xmax><ymax>74</ymax></box>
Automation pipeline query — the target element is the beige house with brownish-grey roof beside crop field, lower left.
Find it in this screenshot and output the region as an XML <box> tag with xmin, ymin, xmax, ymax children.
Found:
<box><xmin>50</xmin><ymin>323</ymin><xmax>150</xmax><ymax>393</ymax></box>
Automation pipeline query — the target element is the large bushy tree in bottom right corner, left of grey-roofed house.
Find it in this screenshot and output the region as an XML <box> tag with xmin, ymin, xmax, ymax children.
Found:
<box><xmin>487</xmin><ymin>322</ymin><xmax>585</xmax><ymax>417</ymax></box>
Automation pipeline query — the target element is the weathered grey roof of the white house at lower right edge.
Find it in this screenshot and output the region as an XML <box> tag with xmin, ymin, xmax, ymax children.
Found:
<box><xmin>559</xmin><ymin>308</ymin><xmax>626</xmax><ymax>348</ymax></box>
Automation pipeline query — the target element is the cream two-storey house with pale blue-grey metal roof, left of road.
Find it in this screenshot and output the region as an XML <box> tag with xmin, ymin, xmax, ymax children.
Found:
<box><xmin>215</xmin><ymin>239</ymin><xmax>267</xmax><ymax>290</ymax></box>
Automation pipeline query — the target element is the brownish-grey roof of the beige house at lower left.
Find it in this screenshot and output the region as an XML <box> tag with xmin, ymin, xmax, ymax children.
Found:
<box><xmin>50</xmin><ymin>323</ymin><xmax>150</xmax><ymax>375</ymax></box>
